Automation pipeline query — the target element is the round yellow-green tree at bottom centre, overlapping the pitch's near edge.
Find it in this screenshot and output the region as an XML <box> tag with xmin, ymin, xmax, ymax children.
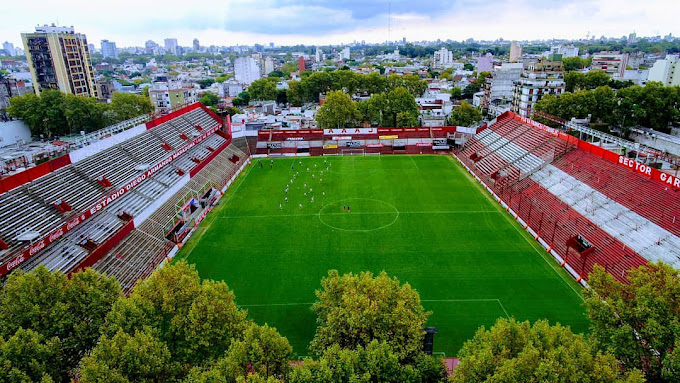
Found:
<box><xmin>309</xmin><ymin>270</ymin><xmax>430</xmax><ymax>361</ymax></box>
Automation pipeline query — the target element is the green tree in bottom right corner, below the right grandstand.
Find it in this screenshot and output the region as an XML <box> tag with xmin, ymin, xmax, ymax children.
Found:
<box><xmin>584</xmin><ymin>262</ymin><xmax>680</xmax><ymax>382</ymax></box>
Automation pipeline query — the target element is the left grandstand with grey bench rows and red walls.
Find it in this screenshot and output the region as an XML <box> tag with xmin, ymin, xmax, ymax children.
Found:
<box><xmin>0</xmin><ymin>103</ymin><xmax>248</xmax><ymax>289</ymax></box>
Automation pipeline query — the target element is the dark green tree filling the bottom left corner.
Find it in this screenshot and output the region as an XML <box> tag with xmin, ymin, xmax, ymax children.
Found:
<box><xmin>0</xmin><ymin>266</ymin><xmax>121</xmax><ymax>381</ymax></box>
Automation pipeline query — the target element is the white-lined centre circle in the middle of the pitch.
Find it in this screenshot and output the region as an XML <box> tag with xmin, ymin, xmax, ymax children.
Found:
<box><xmin>317</xmin><ymin>198</ymin><xmax>399</xmax><ymax>232</ymax></box>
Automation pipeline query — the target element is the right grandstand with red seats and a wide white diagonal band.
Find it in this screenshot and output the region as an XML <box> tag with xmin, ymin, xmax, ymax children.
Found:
<box><xmin>456</xmin><ymin>113</ymin><xmax>680</xmax><ymax>281</ymax></box>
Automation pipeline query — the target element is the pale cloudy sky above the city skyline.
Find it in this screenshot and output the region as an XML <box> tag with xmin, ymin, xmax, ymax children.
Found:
<box><xmin>0</xmin><ymin>0</ymin><xmax>680</xmax><ymax>48</ymax></box>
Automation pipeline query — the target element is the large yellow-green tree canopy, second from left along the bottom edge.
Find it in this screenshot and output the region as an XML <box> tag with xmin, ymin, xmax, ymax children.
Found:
<box><xmin>82</xmin><ymin>262</ymin><xmax>247</xmax><ymax>382</ymax></box>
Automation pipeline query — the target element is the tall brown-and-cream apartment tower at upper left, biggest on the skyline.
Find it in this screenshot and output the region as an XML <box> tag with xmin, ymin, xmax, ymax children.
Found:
<box><xmin>21</xmin><ymin>25</ymin><xmax>97</xmax><ymax>97</ymax></box>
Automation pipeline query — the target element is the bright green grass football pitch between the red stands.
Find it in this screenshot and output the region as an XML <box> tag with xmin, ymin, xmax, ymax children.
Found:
<box><xmin>176</xmin><ymin>156</ymin><xmax>588</xmax><ymax>356</ymax></box>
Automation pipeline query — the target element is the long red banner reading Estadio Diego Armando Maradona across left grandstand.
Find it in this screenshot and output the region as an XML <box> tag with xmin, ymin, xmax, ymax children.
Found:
<box><xmin>0</xmin><ymin>127</ymin><xmax>218</xmax><ymax>276</ymax></box>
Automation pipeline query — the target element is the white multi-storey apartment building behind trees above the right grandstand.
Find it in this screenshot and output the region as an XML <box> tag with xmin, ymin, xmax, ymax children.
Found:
<box><xmin>512</xmin><ymin>54</ymin><xmax>565</xmax><ymax>117</ymax></box>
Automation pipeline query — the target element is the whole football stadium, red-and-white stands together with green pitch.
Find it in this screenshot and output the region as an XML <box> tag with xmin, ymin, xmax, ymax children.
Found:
<box><xmin>0</xmin><ymin>103</ymin><xmax>680</xmax><ymax>380</ymax></box>
